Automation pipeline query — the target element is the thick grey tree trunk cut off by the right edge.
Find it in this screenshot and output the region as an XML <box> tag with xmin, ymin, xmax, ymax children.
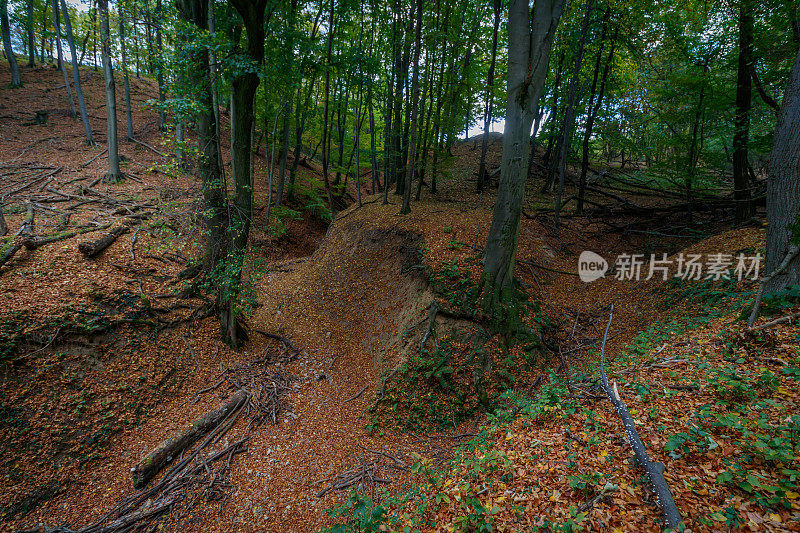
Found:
<box><xmin>764</xmin><ymin>46</ymin><xmax>800</xmax><ymax>293</ymax></box>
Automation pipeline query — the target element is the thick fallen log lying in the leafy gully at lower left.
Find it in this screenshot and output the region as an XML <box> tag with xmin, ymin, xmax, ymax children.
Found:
<box><xmin>131</xmin><ymin>390</ymin><xmax>248</xmax><ymax>489</ymax></box>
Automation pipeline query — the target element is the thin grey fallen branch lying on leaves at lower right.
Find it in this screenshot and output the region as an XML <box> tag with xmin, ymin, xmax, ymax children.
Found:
<box><xmin>600</xmin><ymin>305</ymin><xmax>683</xmax><ymax>529</ymax></box>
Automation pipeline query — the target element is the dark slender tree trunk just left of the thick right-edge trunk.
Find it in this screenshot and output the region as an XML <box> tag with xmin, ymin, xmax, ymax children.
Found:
<box><xmin>733</xmin><ymin>0</ymin><xmax>753</xmax><ymax>224</ymax></box>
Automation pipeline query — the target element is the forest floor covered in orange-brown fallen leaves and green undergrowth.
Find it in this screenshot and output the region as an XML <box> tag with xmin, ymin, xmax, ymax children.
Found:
<box><xmin>0</xmin><ymin>61</ymin><xmax>800</xmax><ymax>532</ymax></box>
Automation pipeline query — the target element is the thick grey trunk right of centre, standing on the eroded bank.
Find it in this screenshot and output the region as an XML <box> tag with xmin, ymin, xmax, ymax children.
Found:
<box><xmin>481</xmin><ymin>0</ymin><xmax>565</xmax><ymax>316</ymax></box>
